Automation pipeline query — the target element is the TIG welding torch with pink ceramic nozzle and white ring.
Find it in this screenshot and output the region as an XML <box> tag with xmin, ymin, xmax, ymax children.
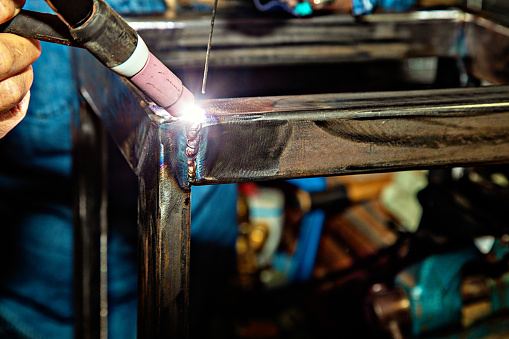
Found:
<box><xmin>0</xmin><ymin>0</ymin><xmax>194</xmax><ymax>117</ymax></box>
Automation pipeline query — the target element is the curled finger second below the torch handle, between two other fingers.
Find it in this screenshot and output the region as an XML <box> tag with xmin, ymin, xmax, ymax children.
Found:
<box><xmin>0</xmin><ymin>66</ymin><xmax>34</xmax><ymax>114</ymax></box>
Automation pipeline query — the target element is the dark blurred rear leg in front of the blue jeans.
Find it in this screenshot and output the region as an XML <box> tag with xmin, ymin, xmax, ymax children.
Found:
<box><xmin>73</xmin><ymin>105</ymin><xmax>108</xmax><ymax>339</ymax></box>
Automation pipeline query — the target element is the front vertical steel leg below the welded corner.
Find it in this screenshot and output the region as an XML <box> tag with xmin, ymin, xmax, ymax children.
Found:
<box><xmin>138</xmin><ymin>125</ymin><xmax>191</xmax><ymax>338</ymax></box>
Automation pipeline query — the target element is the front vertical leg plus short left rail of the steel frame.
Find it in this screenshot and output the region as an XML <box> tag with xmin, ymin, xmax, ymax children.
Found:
<box><xmin>78</xmin><ymin>61</ymin><xmax>190</xmax><ymax>338</ymax></box>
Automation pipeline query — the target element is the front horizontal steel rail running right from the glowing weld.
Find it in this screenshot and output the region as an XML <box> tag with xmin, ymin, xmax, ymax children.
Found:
<box><xmin>194</xmin><ymin>86</ymin><xmax>509</xmax><ymax>184</ymax></box>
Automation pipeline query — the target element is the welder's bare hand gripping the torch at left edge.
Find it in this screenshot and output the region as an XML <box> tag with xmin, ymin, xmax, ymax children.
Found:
<box><xmin>0</xmin><ymin>0</ymin><xmax>41</xmax><ymax>138</ymax></box>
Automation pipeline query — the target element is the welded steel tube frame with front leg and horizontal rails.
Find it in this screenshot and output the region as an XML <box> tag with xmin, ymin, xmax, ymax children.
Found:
<box><xmin>76</xmin><ymin>7</ymin><xmax>509</xmax><ymax>338</ymax></box>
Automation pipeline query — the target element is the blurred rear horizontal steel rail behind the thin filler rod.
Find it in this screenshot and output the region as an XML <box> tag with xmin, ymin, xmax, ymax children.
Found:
<box><xmin>130</xmin><ymin>10</ymin><xmax>465</xmax><ymax>69</ymax></box>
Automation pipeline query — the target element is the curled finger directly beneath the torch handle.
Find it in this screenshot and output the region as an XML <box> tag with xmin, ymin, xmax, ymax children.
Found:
<box><xmin>0</xmin><ymin>33</ymin><xmax>41</xmax><ymax>80</ymax></box>
